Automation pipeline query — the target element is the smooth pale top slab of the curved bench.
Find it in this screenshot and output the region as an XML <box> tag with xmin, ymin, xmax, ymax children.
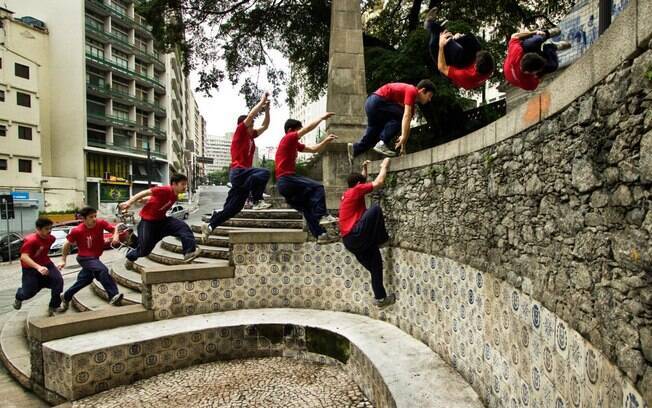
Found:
<box><xmin>43</xmin><ymin>309</ymin><xmax>482</xmax><ymax>408</ymax></box>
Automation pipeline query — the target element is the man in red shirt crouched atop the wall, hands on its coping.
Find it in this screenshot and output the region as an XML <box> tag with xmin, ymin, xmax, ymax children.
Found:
<box><xmin>347</xmin><ymin>79</ymin><xmax>435</xmax><ymax>165</ymax></box>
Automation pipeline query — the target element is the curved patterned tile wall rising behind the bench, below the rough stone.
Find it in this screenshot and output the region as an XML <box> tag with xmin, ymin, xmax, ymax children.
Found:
<box><xmin>140</xmin><ymin>242</ymin><xmax>647</xmax><ymax>408</ymax></box>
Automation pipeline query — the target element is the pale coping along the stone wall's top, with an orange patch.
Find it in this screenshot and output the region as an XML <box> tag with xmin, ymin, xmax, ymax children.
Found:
<box><xmin>369</xmin><ymin>0</ymin><xmax>652</xmax><ymax>174</ymax></box>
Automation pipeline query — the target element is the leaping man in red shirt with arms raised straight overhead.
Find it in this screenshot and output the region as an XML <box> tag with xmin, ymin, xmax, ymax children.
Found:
<box><xmin>202</xmin><ymin>94</ymin><xmax>272</xmax><ymax>242</ymax></box>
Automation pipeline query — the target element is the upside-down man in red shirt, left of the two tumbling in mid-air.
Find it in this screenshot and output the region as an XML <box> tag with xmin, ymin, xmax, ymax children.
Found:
<box><xmin>425</xmin><ymin>8</ymin><xmax>495</xmax><ymax>89</ymax></box>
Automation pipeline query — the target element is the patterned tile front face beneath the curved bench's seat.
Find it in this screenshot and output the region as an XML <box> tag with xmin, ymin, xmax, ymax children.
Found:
<box><xmin>43</xmin><ymin>325</ymin><xmax>395</xmax><ymax>407</ymax></box>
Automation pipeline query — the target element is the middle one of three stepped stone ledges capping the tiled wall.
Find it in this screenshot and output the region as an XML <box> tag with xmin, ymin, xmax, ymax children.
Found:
<box><xmin>141</xmin><ymin>261</ymin><xmax>234</xmax><ymax>285</ymax></box>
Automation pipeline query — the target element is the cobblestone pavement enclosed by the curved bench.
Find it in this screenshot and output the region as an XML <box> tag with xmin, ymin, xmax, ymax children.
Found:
<box><xmin>73</xmin><ymin>357</ymin><xmax>373</xmax><ymax>408</ymax></box>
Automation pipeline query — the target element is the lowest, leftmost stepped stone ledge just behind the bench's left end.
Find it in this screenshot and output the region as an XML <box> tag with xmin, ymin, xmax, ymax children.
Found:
<box><xmin>27</xmin><ymin>305</ymin><xmax>154</xmax><ymax>343</ymax></box>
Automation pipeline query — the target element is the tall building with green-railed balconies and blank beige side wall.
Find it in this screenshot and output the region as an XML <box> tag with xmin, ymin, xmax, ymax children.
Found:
<box><xmin>6</xmin><ymin>0</ymin><xmax>204</xmax><ymax>214</ymax></box>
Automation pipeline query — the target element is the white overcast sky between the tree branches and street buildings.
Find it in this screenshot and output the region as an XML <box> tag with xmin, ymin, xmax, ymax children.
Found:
<box><xmin>190</xmin><ymin>55</ymin><xmax>289</xmax><ymax>157</ymax></box>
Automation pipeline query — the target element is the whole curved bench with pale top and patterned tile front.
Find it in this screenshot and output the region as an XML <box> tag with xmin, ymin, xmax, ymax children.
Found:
<box><xmin>43</xmin><ymin>309</ymin><xmax>482</xmax><ymax>408</ymax></box>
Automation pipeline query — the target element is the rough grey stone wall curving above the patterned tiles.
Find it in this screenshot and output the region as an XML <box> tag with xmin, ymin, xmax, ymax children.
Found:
<box><xmin>378</xmin><ymin>43</ymin><xmax>652</xmax><ymax>400</ymax></box>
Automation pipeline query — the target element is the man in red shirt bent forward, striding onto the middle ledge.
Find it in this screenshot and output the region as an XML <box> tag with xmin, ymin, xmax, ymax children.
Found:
<box><xmin>119</xmin><ymin>173</ymin><xmax>201</xmax><ymax>270</ymax></box>
